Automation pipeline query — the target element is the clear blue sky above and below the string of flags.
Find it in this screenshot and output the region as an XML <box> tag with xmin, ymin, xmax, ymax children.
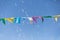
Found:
<box><xmin>0</xmin><ymin>0</ymin><xmax>60</xmax><ymax>40</ymax></box>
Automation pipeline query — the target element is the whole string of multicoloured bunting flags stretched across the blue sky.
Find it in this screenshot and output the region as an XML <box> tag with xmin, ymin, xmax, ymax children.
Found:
<box><xmin>0</xmin><ymin>15</ymin><xmax>60</xmax><ymax>24</ymax></box>
